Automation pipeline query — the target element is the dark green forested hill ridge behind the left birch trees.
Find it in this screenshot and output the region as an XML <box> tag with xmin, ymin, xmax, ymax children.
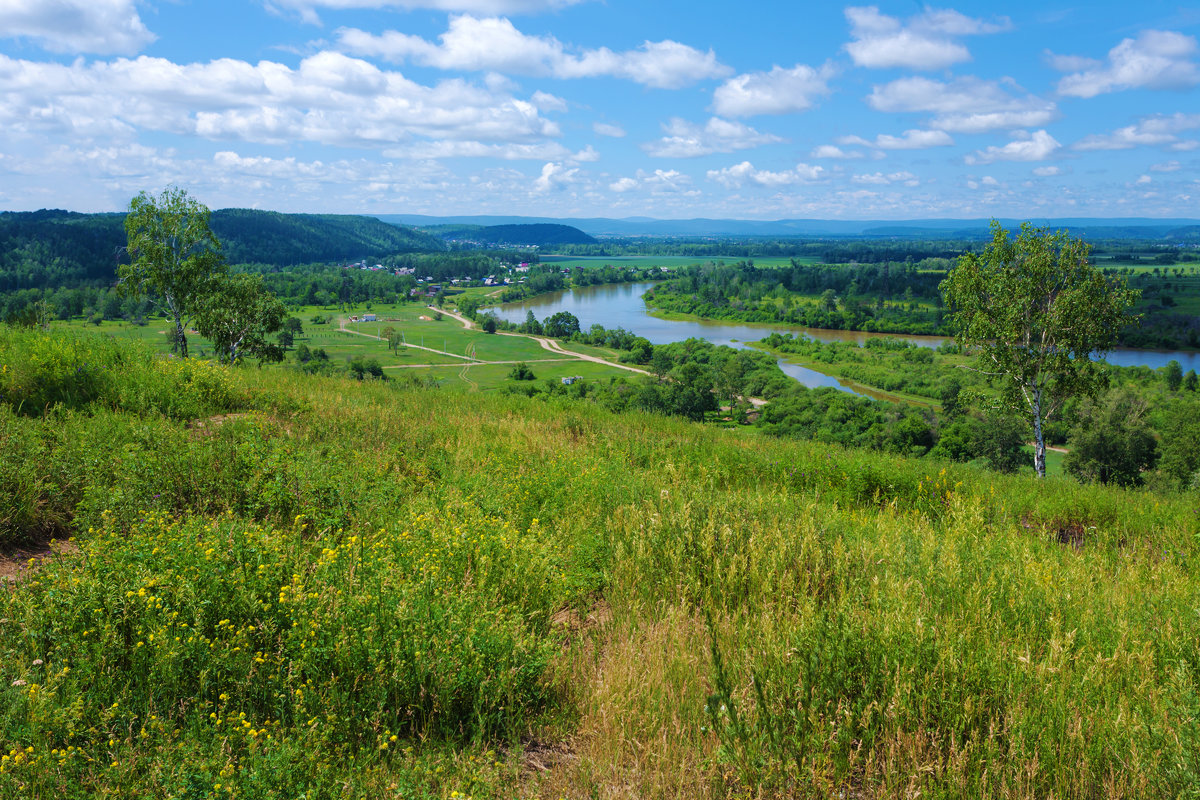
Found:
<box><xmin>0</xmin><ymin>209</ymin><xmax>446</xmax><ymax>291</ymax></box>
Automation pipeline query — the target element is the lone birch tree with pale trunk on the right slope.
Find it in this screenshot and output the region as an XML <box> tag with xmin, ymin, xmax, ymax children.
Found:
<box><xmin>942</xmin><ymin>219</ymin><xmax>1139</xmax><ymax>477</ymax></box>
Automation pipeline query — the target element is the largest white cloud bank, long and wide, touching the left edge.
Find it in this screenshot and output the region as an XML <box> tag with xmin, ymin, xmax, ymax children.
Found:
<box><xmin>0</xmin><ymin>52</ymin><xmax>559</xmax><ymax>149</ymax></box>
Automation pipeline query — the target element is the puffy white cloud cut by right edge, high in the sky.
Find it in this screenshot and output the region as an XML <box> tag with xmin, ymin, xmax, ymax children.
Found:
<box><xmin>1057</xmin><ymin>30</ymin><xmax>1200</xmax><ymax>97</ymax></box>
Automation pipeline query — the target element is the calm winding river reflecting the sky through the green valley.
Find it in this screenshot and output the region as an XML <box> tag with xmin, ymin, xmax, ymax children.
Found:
<box><xmin>493</xmin><ymin>283</ymin><xmax>1200</xmax><ymax>393</ymax></box>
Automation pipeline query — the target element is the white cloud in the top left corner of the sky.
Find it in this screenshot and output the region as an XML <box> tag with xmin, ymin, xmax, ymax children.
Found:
<box><xmin>0</xmin><ymin>0</ymin><xmax>156</xmax><ymax>55</ymax></box>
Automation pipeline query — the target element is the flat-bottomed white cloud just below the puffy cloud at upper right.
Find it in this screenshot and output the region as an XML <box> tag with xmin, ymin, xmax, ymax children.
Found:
<box><xmin>866</xmin><ymin>77</ymin><xmax>1057</xmax><ymax>133</ymax></box>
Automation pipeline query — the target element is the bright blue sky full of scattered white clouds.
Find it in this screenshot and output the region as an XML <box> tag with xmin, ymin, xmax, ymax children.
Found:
<box><xmin>0</xmin><ymin>0</ymin><xmax>1200</xmax><ymax>219</ymax></box>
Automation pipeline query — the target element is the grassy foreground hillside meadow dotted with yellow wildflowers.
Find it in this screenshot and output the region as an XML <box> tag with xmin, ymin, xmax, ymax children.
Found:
<box><xmin>0</xmin><ymin>330</ymin><xmax>1200</xmax><ymax>799</ymax></box>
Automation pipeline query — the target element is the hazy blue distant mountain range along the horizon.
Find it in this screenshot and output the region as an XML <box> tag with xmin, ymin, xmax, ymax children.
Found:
<box><xmin>379</xmin><ymin>213</ymin><xmax>1200</xmax><ymax>241</ymax></box>
